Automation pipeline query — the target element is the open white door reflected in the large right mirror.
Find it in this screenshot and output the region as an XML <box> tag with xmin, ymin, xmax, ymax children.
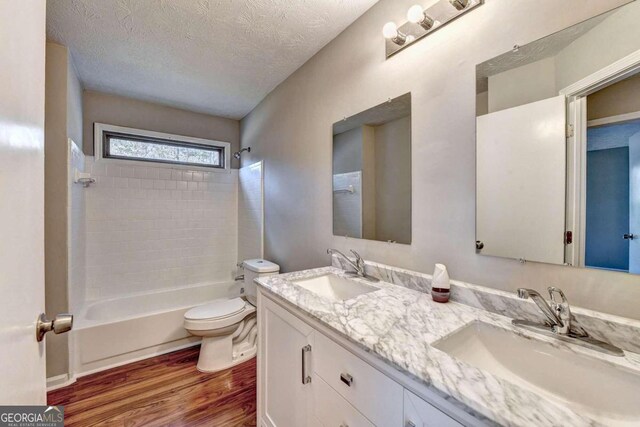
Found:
<box><xmin>476</xmin><ymin>96</ymin><xmax>566</xmax><ymax>264</ymax></box>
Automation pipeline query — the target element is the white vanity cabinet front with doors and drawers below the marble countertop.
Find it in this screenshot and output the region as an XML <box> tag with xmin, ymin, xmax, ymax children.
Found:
<box><xmin>258</xmin><ymin>292</ymin><xmax>478</xmax><ymax>427</ymax></box>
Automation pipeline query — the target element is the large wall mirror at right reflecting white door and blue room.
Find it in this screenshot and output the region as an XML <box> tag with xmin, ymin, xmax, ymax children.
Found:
<box><xmin>476</xmin><ymin>2</ymin><xmax>640</xmax><ymax>274</ymax></box>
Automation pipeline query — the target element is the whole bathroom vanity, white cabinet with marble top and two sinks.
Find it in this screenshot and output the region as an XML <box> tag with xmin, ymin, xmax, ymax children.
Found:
<box><xmin>258</xmin><ymin>257</ymin><xmax>640</xmax><ymax>427</ymax></box>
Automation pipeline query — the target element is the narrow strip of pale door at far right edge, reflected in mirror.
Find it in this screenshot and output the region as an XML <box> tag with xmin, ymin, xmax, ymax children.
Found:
<box><xmin>628</xmin><ymin>133</ymin><xmax>640</xmax><ymax>274</ymax></box>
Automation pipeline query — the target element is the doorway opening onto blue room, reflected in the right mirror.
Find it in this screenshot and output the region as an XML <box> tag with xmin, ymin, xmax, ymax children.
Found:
<box><xmin>584</xmin><ymin>74</ymin><xmax>640</xmax><ymax>273</ymax></box>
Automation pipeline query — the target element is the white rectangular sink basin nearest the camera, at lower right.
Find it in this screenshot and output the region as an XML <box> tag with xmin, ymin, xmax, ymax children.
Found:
<box><xmin>433</xmin><ymin>322</ymin><xmax>640</xmax><ymax>426</ymax></box>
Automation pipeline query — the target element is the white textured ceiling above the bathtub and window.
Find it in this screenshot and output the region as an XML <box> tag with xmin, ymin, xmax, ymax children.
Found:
<box><xmin>47</xmin><ymin>0</ymin><xmax>377</xmax><ymax>119</ymax></box>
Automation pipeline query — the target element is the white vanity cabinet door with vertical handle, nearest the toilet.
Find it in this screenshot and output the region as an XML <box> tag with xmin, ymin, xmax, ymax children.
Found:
<box><xmin>258</xmin><ymin>293</ymin><xmax>313</xmax><ymax>427</ymax></box>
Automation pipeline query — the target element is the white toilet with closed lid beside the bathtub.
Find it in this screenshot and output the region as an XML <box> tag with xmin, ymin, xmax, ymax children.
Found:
<box><xmin>184</xmin><ymin>259</ymin><xmax>280</xmax><ymax>372</ymax></box>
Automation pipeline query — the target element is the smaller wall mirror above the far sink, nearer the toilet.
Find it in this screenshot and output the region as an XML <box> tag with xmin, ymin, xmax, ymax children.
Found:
<box><xmin>333</xmin><ymin>93</ymin><xmax>411</xmax><ymax>244</ymax></box>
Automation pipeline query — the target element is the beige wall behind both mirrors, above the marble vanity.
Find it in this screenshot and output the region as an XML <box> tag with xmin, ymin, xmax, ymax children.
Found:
<box><xmin>242</xmin><ymin>0</ymin><xmax>640</xmax><ymax>319</ymax></box>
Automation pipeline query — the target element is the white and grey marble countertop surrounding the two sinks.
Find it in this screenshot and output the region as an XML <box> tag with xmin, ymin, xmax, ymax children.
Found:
<box><xmin>257</xmin><ymin>267</ymin><xmax>640</xmax><ymax>426</ymax></box>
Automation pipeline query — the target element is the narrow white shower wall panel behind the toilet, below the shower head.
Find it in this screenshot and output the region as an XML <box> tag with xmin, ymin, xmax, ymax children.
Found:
<box><xmin>238</xmin><ymin>162</ymin><xmax>264</xmax><ymax>261</ymax></box>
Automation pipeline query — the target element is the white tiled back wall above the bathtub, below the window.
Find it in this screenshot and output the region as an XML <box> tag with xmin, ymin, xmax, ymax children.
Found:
<box><xmin>85</xmin><ymin>157</ymin><xmax>238</xmax><ymax>300</ymax></box>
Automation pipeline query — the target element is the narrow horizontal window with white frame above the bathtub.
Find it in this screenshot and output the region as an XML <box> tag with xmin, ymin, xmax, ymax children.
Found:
<box><xmin>94</xmin><ymin>123</ymin><xmax>230</xmax><ymax>171</ymax></box>
